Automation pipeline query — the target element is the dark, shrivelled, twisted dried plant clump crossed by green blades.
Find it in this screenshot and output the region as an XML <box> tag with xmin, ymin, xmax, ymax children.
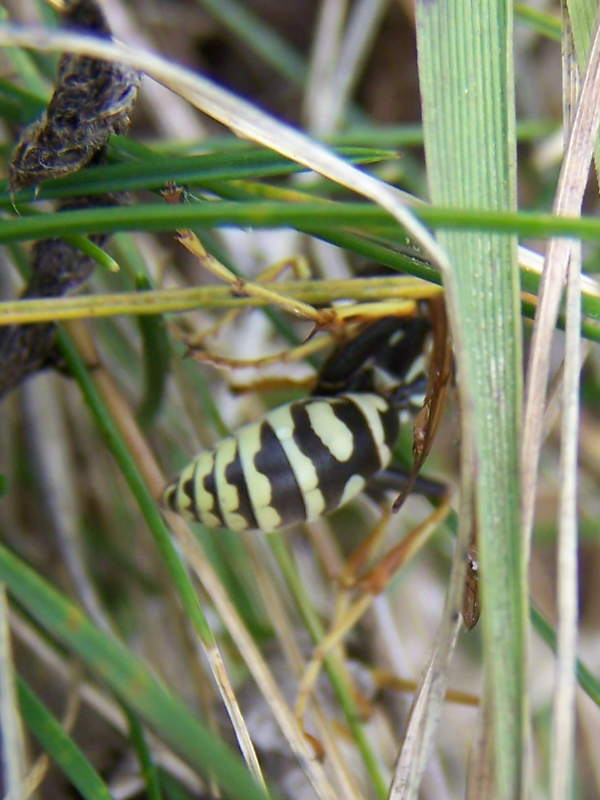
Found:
<box><xmin>0</xmin><ymin>0</ymin><xmax>140</xmax><ymax>397</ymax></box>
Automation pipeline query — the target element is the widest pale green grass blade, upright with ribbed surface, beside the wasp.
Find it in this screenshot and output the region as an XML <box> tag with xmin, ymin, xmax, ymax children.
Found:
<box><xmin>417</xmin><ymin>0</ymin><xmax>527</xmax><ymax>800</ymax></box>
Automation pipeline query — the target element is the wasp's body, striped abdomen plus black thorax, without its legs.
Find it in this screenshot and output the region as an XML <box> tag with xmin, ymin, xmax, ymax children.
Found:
<box><xmin>163</xmin><ymin>318</ymin><xmax>428</xmax><ymax>531</ymax></box>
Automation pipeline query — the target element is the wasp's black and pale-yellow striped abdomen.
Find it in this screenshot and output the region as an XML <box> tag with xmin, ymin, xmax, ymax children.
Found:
<box><xmin>163</xmin><ymin>393</ymin><xmax>399</xmax><ymax>531</ymax></box>
